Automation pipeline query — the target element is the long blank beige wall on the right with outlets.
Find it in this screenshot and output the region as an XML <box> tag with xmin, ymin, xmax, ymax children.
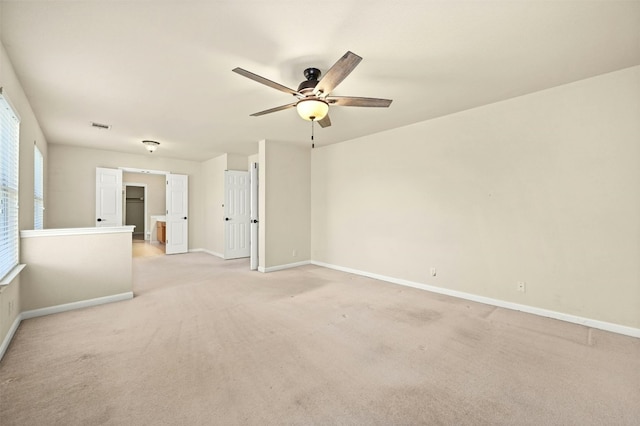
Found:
<box><xmin>312</xmin><ymin>67</ymin><xmax>640</xmax><ymax>328</ymax></box>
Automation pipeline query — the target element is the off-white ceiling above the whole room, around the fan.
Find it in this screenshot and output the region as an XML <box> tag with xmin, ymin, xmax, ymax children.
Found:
<box><xmin>0</xmin><ymin>0</ymin><xmax>640</xmax><ymax>160</ymax></box>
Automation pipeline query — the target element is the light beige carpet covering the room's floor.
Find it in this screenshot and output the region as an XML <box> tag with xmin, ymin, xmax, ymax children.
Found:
<box><xmin>0</xmin><ymin>253</ymin><xmax>640</xmax><ymax>426</ymax></box>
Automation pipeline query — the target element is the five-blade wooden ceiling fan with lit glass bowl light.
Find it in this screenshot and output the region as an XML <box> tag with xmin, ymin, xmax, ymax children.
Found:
<box><xmin>233</xmin><ymin>52</ymin><xmax>392</xmax><ymax>127</ymax></box>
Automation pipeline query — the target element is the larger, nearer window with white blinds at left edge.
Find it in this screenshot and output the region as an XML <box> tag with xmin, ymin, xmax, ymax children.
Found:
<box><xmin>0</xmin><ymin>87</ymin><xmax>20</xmax><ymax>278</ymax></box>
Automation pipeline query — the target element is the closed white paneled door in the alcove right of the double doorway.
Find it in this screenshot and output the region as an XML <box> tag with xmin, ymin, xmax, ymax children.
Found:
<box><xmin>224</xmin><ymin>170</ymin><xmax>251</xmax><ymax>259</ymax></box>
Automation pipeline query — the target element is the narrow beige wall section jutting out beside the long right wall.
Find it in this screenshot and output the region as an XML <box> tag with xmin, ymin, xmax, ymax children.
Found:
<box><xmin>258</xmin><ymin>141</ymin><xmax>311</xmax><ymax>270</ymax></box>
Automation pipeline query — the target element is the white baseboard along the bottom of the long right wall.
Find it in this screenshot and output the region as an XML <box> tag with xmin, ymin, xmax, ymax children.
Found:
<box><xmin>311</xmin><ymin>260</ymin><xmax>640</xmax><ymax>338</ymax></box>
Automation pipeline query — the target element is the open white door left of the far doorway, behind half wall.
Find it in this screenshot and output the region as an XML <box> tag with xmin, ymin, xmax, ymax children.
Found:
<box><xmin>96</xmin><ymin>167</ymin><xmax>122</xmax><ymax>227</ymax></box>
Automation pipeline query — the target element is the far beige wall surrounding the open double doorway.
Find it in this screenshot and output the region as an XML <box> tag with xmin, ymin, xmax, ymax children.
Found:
<box><xmin>47</xmin><ymin>144</ymin><xmax>204</xmax><ymax>249</ymax></box>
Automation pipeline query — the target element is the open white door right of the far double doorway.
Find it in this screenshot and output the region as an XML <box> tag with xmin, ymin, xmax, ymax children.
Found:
<box><xmin>165</xmin><ymin>174</ymin><xmax>189</xmax><ymax>254</ymax></box>
